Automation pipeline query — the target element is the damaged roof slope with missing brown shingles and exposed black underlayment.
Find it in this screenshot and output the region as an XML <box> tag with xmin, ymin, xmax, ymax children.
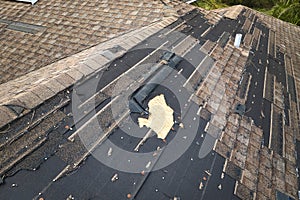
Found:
<box><xmin>0</xmin><ymin>1</ymin><xmax>300</xmax><ymax>199</ymax></box>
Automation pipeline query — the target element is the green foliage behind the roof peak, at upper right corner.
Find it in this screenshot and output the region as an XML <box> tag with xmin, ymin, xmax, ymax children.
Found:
<box><xmin>193</xmin><ymin>0</ymin><xmax>300</xmax><ymax>26</ymax></box>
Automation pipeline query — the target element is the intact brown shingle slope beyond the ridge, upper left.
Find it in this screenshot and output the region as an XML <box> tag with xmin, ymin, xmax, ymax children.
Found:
<box><xmin>0</xmin><ymin>0</ymin><xmax>192</xmax><ymax>84</ymax></box>
